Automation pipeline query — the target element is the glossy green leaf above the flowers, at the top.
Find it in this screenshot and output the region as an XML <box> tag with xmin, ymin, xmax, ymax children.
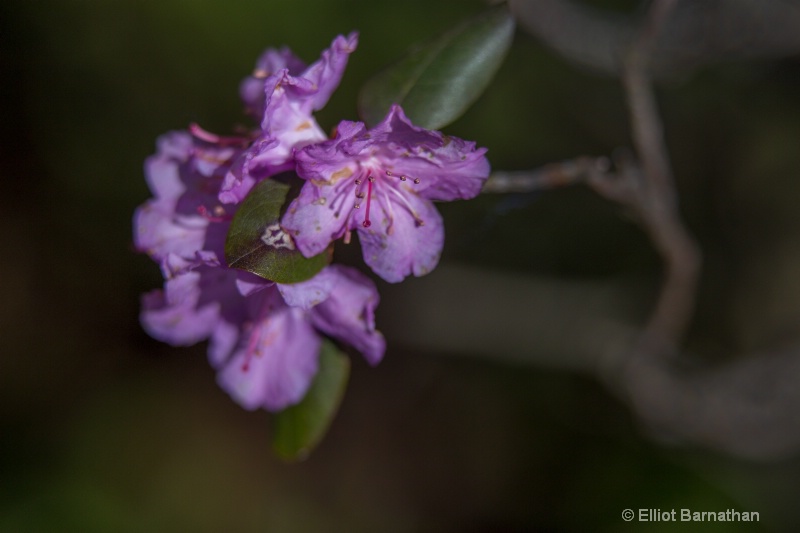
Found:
<box><xmin>359</xmin><ymin>5</ymin><xmax>514</xmax><ymax>129</ymax></box>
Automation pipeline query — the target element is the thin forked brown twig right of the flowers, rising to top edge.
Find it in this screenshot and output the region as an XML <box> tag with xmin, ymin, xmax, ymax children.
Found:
<box><xmin>484</xmin><ymin>0</ymin><xmax>700</xmax><ymax>352</ymax></box>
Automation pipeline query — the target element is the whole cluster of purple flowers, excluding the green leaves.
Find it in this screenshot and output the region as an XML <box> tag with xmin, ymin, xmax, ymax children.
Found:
<box><xmin>134</xmin><ymin>34</ymin><xmax>489</xmax><ymax>411</ymax></box>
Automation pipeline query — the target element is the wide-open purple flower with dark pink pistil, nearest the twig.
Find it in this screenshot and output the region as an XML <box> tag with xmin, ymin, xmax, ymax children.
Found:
<box><xmin>282</xmin><ymin>105</ymin><xmax>489</xmax><ymax>282</ymax></box>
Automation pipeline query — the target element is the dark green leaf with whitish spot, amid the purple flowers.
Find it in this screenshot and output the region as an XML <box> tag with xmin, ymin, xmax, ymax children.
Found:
<box><xmin>225</xmin><ymin>179</ymin><xmax>330</xmax><ymax>283</ymax></box>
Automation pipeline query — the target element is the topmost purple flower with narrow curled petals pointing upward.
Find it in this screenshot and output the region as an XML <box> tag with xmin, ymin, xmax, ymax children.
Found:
<box><xmin>219</xmin><ymin>33</ymin><xmax>358</xmax><ymax>204</ymax></box>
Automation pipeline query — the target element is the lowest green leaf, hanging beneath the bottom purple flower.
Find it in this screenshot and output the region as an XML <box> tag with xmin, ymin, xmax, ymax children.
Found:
<box><xmin>272</xmin><ymin>339</ymin><xmax>350</xmax><ymax>461</ymax></box>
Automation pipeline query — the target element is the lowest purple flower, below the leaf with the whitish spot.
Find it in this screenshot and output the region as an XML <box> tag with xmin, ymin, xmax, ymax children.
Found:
<box><xmin>142</xmin><ymin>259</ymin><xmax>385</xmax><ymax>411</ymax></box>
